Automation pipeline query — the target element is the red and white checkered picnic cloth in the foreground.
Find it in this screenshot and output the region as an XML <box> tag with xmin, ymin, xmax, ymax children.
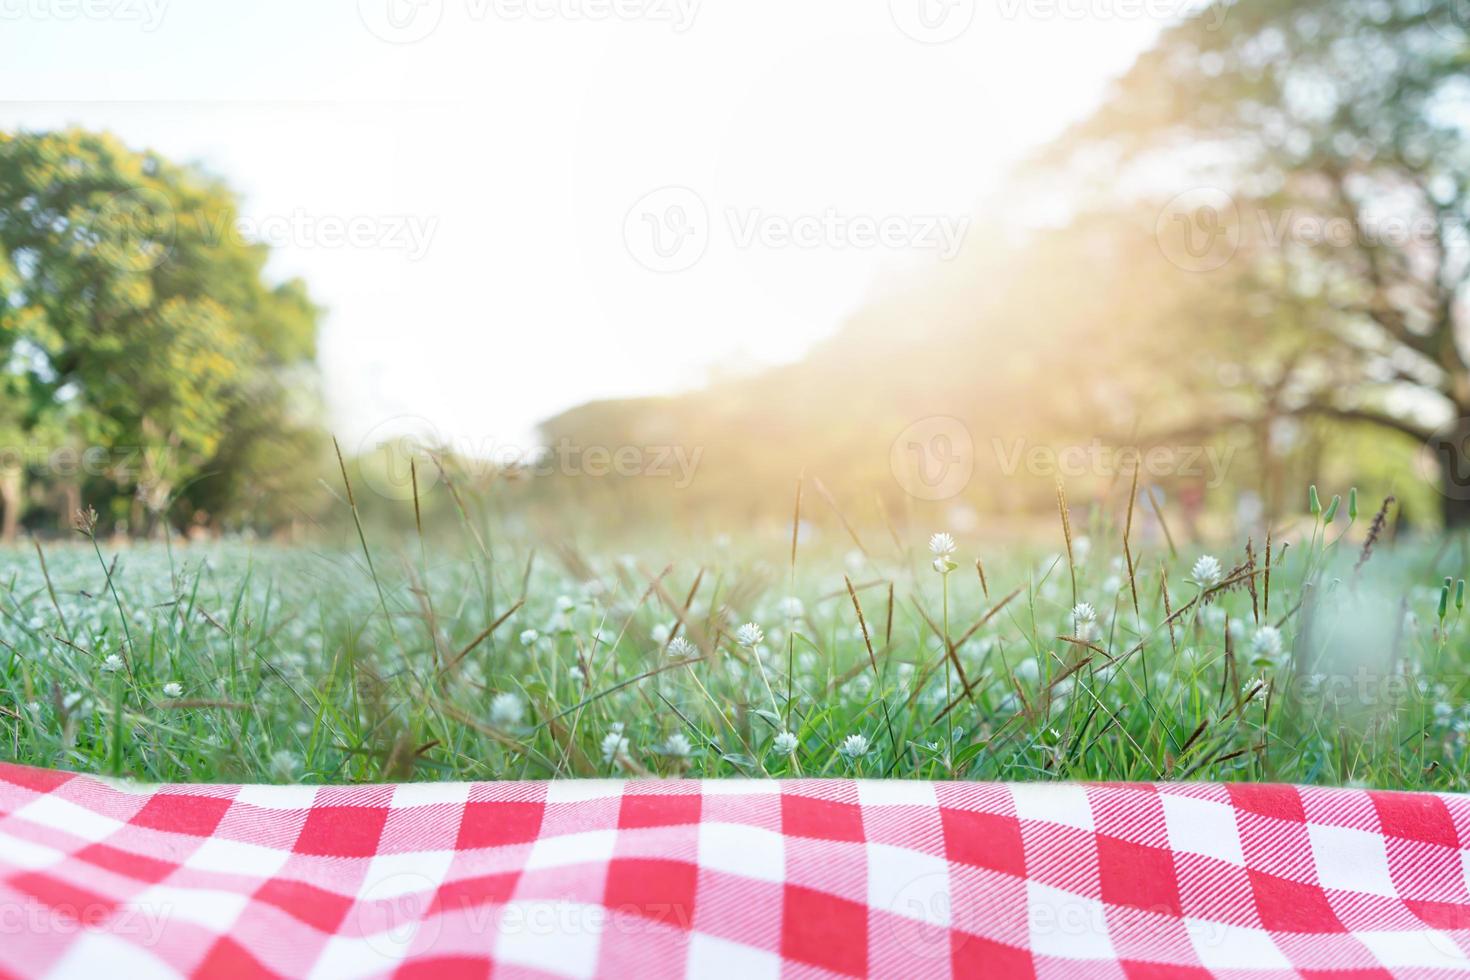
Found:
<box><xmin>0</xmin><ymin>764</ymin><xmax>1470</xmax><ymax>979</ymax></box>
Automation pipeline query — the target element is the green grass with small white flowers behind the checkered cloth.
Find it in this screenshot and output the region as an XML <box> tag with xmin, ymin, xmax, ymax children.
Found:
<box><xmin>0</xmin><ymin>490</ymin><xmax>1470</xmax><ymax>789</ymax></box>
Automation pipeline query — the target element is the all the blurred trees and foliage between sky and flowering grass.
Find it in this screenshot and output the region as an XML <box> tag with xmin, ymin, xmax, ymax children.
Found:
<box><xmin>0</xmin><ymin>0</ymin><xmax>1470</xmax><ymax>535</ymax></box>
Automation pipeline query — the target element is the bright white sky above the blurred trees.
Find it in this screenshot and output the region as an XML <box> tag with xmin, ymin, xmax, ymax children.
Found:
<box><xmin>0</xmin><ymin>0</ymin><xmax>1182</xmax><ymax>454</ymax></box>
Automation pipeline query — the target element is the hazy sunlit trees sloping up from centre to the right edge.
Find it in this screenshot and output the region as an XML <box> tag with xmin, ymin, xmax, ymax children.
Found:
<box><xmin>544</xmin><ymin>0</ymin><xmax>1470</xmax><ymax>526</ymax></box>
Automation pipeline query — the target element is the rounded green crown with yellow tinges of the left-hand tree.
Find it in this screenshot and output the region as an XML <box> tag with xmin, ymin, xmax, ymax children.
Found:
<box><xmin>0</xmin><ymin>129</ymin><xmax>319</xmax><ymax>532</ymax></box>
